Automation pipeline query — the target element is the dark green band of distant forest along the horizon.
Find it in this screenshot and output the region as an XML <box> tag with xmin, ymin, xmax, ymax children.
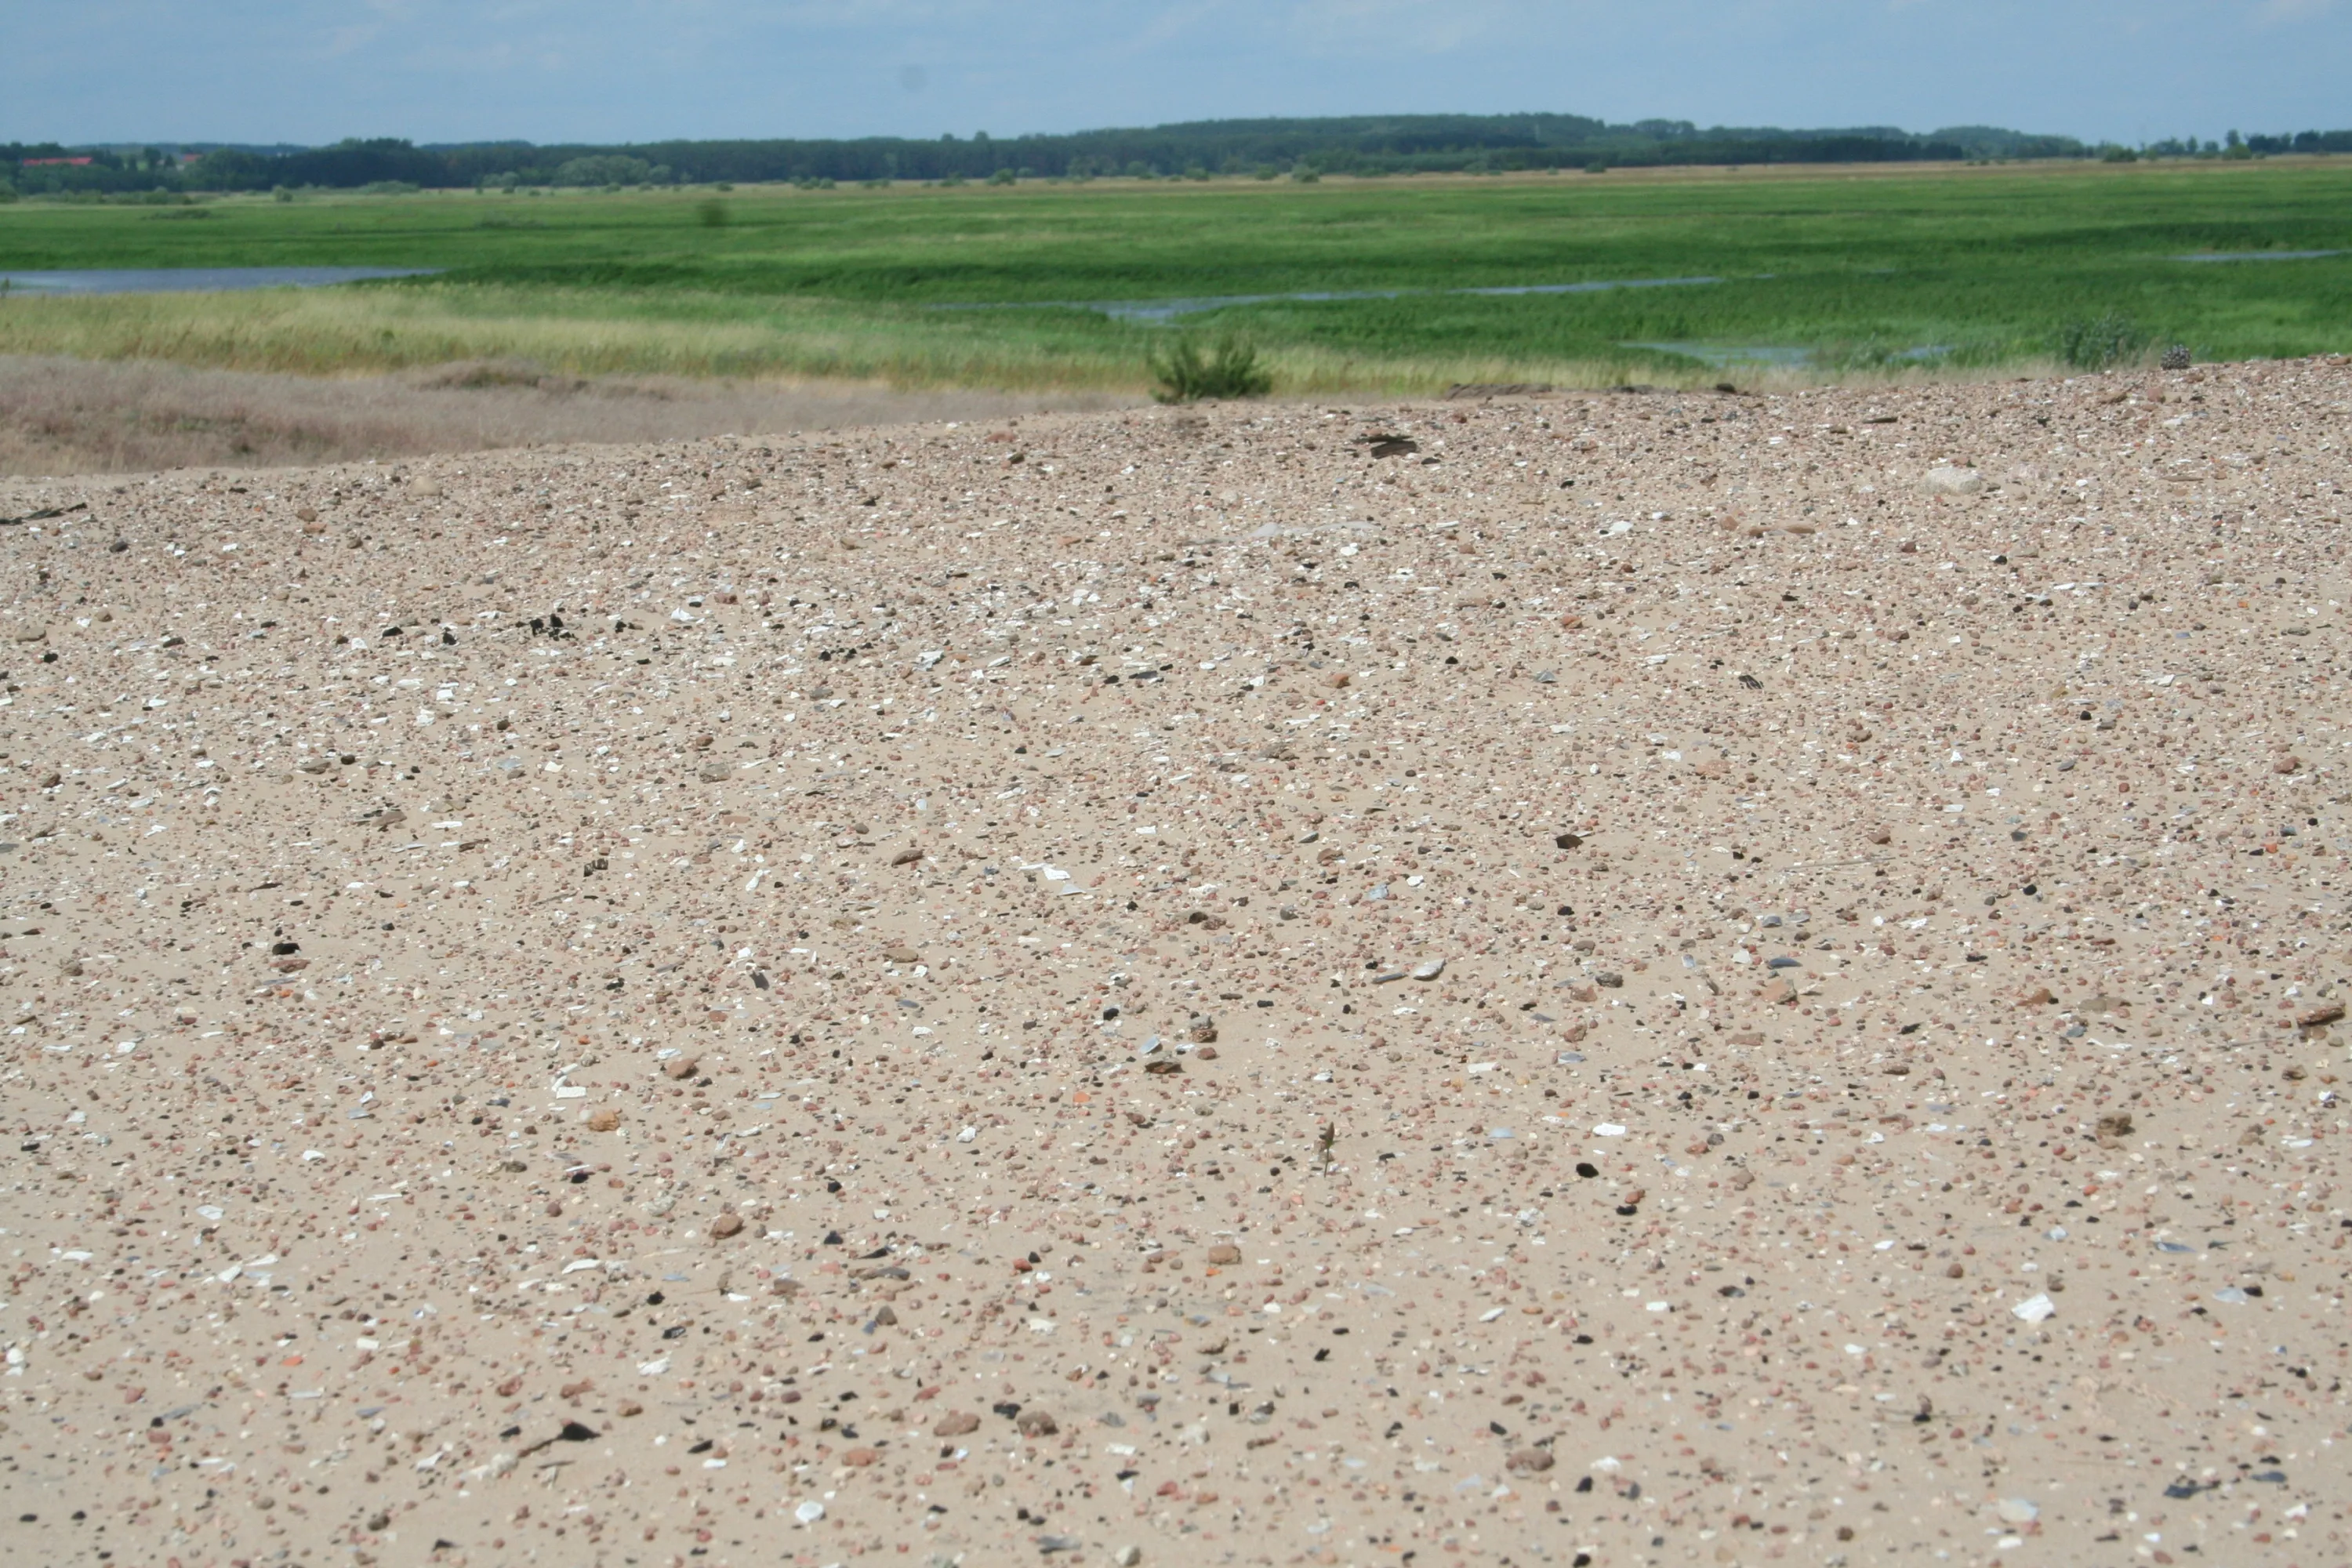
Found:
<box><xmin>13</xmin><ymin>115</ymin><xmax>2352</xmax><ymax>198</ymax></box>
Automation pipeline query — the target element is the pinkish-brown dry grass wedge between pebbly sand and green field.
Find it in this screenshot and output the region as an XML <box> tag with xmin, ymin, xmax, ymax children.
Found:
<box><xmin>0</xmin><ymin>355</ymin><xmax>1141</xmax><ymax>477</ymax></box>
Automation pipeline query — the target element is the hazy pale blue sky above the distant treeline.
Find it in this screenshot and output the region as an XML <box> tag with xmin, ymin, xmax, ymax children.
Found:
<box><xmin>0</xmin><ymin>0</ymin><xmax>2352</xmax><ymax>143</ymax></box>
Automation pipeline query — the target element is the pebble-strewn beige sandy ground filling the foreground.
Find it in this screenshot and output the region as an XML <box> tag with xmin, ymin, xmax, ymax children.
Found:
<box><xmin>0</xmin><ymin>362</ymin><xmax>2352</xmax><ymax>1568</ymax></box>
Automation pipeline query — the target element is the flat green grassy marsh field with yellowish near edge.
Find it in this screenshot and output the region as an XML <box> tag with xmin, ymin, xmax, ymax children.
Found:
<box><xmin>0</xmin><ymin>160</ymin><xmax>2352</xmax><ymax>393</ymax></box>
